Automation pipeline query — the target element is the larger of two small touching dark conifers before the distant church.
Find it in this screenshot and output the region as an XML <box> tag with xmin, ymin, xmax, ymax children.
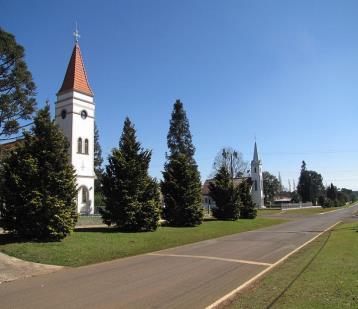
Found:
<box><xmin>209</xmin><ymin>166</ymin><xmax>240</xmax><ymax>220</ymax></box>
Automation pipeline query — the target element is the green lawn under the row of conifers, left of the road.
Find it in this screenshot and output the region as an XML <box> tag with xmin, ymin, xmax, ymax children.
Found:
<box><xmin>0</xmin><ymin>218</ymin><xmax>285</xmax><ymax>267</ymax></box>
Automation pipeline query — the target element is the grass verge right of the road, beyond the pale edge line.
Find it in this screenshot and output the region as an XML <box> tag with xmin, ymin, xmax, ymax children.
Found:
<box><xmin>227</xmin><ymin>223</ymin><xmax>358</xmax><ymax>309</ymax></box>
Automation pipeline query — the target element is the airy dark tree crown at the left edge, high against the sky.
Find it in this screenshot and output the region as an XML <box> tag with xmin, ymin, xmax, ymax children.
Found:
<box><xmin>0</xmin><ymin>27</ymin><xmax>36</xmax><ymax>139</ymax></box>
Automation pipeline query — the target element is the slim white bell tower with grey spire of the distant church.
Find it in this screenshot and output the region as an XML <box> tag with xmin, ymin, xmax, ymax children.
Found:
<box><xmin>251</xmin><ymin>142</ymin><xmax>265</xmax><ymax>208</ymax></box>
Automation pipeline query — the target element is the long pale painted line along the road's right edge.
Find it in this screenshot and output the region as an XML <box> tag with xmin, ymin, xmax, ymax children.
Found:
<box><xmin>205</xmin><ymin>221</ymin><xmax>342</xmax><ymax>309</ymax></box>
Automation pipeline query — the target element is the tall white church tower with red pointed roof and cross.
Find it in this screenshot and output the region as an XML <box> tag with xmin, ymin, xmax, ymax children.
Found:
<box><xmin>55</xmin><ymin>30</ymin><xmax>95</xmax><ymax>214</ymax></box>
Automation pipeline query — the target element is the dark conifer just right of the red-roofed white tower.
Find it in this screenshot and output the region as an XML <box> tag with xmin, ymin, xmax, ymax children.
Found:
<box><xmin>100</xmin><ymin>118</ymin><xmax>160</xmax><ymax>231</ymax></box>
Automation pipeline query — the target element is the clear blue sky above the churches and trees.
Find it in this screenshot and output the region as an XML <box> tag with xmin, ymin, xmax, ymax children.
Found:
<box><xmin>0</xmin><ymin>0</ymin><xmax>358</xmax><ymax>190</ymax></box>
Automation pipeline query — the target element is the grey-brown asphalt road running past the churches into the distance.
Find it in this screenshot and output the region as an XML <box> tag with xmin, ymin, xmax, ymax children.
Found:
<box><xmin>0</xmin><ymin>206</ymin><xmax>358</xmax><ymax>309</ymax></box>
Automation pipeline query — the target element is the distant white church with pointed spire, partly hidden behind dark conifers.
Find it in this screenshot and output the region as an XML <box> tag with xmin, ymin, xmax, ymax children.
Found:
<box><xmin>202</xmin><ymin>142</ymin><xmax>265</xmax><ymax>212</ymax></box>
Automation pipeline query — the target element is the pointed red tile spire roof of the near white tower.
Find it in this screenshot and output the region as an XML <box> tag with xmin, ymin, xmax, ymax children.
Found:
<box><xmin>58</xmin><ymin>43</ymin><xmax>93</xmax><ymax>96</ymax></box>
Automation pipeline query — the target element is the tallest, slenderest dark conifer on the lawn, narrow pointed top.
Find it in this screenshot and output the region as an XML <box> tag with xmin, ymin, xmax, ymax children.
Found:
<box><xmin>161</xmin><ymin>100</ymin><xmax>203</xmax><ymax>226</ymax></box>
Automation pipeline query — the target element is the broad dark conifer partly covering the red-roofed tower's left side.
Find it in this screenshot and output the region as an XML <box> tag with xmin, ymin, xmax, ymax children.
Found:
<box><xmin>0</xmin><ymin>106</ymin><xmax>77</xmax><ymax>240</ymax></box>
